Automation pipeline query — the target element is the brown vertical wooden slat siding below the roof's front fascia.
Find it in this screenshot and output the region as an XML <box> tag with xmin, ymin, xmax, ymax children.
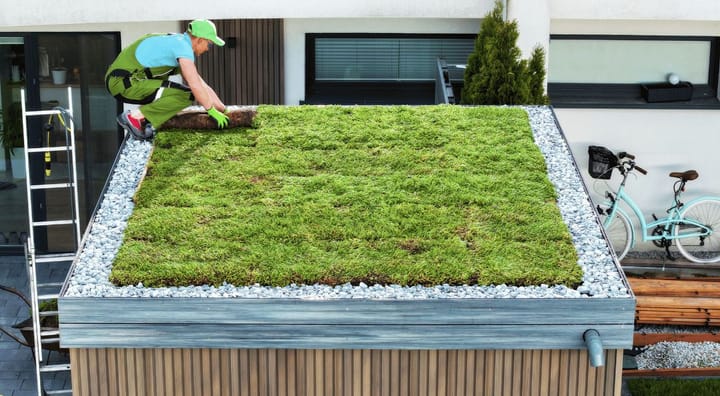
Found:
<box><xmin>70</xmin><ymin>348</ymin><xmax>623</xmax><ymax>396</ymax></box>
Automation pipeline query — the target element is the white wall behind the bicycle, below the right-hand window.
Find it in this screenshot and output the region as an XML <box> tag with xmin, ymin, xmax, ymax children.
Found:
<box><xmin>555</xmin><ymin>109</ymin><xmax>720</xmax><ymax>251</ymax></box>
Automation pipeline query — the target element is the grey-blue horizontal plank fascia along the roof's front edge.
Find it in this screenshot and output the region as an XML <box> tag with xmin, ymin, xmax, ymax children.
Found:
<box><xmin>58</xmin><ymin>296</ymin><xmax>635</xmax><ymax>350</ymax></box>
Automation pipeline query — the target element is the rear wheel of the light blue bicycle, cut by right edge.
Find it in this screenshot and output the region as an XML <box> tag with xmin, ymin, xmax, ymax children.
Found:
<box><xmin>673</xmin><ymin>199</ymin><xmax>720</xmax><ymax>263</ymax></box>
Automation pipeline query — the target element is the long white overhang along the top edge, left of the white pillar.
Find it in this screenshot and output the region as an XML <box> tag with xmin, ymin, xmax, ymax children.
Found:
<box><xmin>0</xmin><ymin>0</ymin><xmax>494</xmax><ymax>26</ymax></box>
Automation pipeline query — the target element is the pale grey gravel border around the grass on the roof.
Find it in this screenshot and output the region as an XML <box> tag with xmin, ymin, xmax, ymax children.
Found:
<box><xmin>65</xmin><ymin>107</ymin><xmax>630</xmax><ymax>299</ymax></box>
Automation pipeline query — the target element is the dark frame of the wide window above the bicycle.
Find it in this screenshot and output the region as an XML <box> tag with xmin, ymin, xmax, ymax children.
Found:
<box><xmin>547</xmin><ymin>34</ymin><xmax>720</xmax><ymax>109</ymax></box>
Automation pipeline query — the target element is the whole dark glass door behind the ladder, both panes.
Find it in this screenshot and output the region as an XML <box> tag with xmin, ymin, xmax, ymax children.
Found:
<box><xmin>0</xmin><ymin>32</ymin><xmax>123</xmax><ymax>254</ymax></box>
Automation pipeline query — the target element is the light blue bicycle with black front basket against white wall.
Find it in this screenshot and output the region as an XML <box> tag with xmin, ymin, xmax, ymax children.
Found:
<box><xmin>588</xmin><ymin>146</ymin><xmax>720</xmax><ymax>263</ymax></box>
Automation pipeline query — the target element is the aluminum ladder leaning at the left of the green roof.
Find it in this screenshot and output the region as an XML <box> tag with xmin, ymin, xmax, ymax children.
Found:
<box><xmin>20</xmin><ymin>87</ymin><xmax>81</xmax><ymax>396</ymax></box>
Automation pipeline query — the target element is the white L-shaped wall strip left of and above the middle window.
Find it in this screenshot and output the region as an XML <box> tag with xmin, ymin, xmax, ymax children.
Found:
<box><xmin>285</xmin><ymin>18</ymin><xmax>480</xmax><ymax>105</ymax></box>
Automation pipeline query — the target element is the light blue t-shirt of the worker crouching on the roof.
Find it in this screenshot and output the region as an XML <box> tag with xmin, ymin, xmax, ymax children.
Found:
<box><xmin>135</xmin><ymin>33</ymin><xmax>195</xmax><ymax>67</ymax></box>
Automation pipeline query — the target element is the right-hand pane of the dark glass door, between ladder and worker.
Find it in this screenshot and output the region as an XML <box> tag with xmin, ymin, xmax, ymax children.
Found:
<box><xmin>31</xmin><ymin>32</ymin><xmax>122</xmax><ymax>252</ymax></box>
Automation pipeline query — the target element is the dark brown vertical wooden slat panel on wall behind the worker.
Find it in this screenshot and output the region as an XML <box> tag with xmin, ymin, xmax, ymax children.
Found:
<box><xmin>191</xmin><ymin>19</ymin><xmax>284</xmax><ymax>105</ymax></box>
